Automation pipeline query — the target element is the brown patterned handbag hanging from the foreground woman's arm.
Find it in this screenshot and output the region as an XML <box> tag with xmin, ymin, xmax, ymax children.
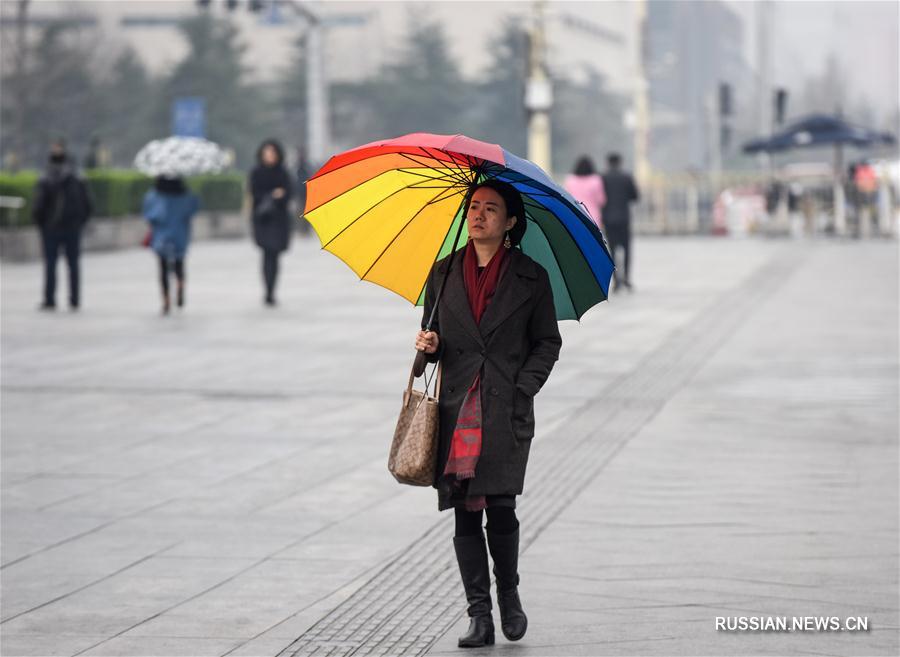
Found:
<box><xmin>388</xmin><ymin>362</ymin><xmax>441</xmax><ymax>486</ymax></box>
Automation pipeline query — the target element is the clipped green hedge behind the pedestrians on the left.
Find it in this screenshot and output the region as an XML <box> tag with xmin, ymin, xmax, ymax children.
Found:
<box><xmin>0</xmin><ymin>169</ymin><xmax>244</xmax><ymax>226</ymax></box>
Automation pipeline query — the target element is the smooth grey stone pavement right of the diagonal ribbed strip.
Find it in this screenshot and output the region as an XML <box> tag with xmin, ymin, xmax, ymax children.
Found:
<box><xmin>430</xmin><ymin>241</ymin><xmax>898</xmax><ymax>655</ymax></box>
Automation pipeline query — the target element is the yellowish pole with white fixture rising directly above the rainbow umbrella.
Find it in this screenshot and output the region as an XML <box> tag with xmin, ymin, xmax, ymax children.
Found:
<box><xmin>525</xmin><ymin>0</ymin><xmax>553</xmax><ymax>173</ymax></box>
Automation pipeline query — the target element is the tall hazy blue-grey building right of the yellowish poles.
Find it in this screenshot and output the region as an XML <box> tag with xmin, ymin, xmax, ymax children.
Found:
<box><xmin>644</xmin><ymin>0</ymin><xmax>753</xmax><ymax>170</ymax></box>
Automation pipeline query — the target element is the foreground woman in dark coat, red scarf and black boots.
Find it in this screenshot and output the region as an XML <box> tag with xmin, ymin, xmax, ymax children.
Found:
<box><xmin>416</xmin><ymin>180</ymin><xmax>562</xmax><ymax>647</ymax></box>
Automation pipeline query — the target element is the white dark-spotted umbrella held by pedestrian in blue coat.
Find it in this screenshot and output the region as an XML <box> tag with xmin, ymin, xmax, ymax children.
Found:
<box><xmin>134</xmin><ymin>137</ymin><xmax>230</xmax><ymax>178</ymax></box>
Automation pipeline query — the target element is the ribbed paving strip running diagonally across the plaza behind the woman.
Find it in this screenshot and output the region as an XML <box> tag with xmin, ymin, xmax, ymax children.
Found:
<box><xmin>268</xmin><ymin>242</ymin><xmax>803</xmax><ymax>657</ymax></box>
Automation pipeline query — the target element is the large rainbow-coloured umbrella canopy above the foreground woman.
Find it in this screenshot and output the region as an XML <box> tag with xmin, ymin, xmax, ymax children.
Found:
<box><xmin>304</xmin><ymin>133</ymin><xmax>614</xmax><ymax>319</ymax></box>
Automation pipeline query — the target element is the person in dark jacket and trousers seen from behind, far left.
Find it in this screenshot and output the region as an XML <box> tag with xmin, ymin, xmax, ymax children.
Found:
<box><xmin>32</xmin><ymin>141</ymin><xmax>92</xmax><ymax>310</ymax></box>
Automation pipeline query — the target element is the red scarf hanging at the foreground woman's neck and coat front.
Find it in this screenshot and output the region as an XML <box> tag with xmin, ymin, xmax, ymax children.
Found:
<box><xmin>444</xmin><ymin>241</ymin><xmax>509</xmax><ymax>511</ymax></box>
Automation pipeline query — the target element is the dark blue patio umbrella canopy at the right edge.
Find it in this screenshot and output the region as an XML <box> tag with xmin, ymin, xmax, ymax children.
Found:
<box><xmin>743</xmin><ymin>114</ymin><xmax>895</xmax><ymax>153</ymax></box>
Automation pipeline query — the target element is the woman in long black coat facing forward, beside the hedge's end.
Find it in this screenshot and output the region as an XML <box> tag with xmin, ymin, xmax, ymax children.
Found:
<box><xmin>250</xmin><ymin>139</ymin><xmax>292</xmax><ymax>306</ymax></box>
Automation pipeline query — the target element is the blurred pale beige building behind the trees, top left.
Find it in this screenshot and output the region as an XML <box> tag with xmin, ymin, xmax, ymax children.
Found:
<box><xmin>2</xmin><ymin>0</ymin><xmax>636</xmax><ymax>93</ymax></box>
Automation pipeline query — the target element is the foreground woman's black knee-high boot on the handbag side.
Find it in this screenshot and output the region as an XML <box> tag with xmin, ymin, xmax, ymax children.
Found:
<box><xmin>453</xmin><ymin>532</ymin><xmax>494</xmax><ymax>648</ymax></box>
